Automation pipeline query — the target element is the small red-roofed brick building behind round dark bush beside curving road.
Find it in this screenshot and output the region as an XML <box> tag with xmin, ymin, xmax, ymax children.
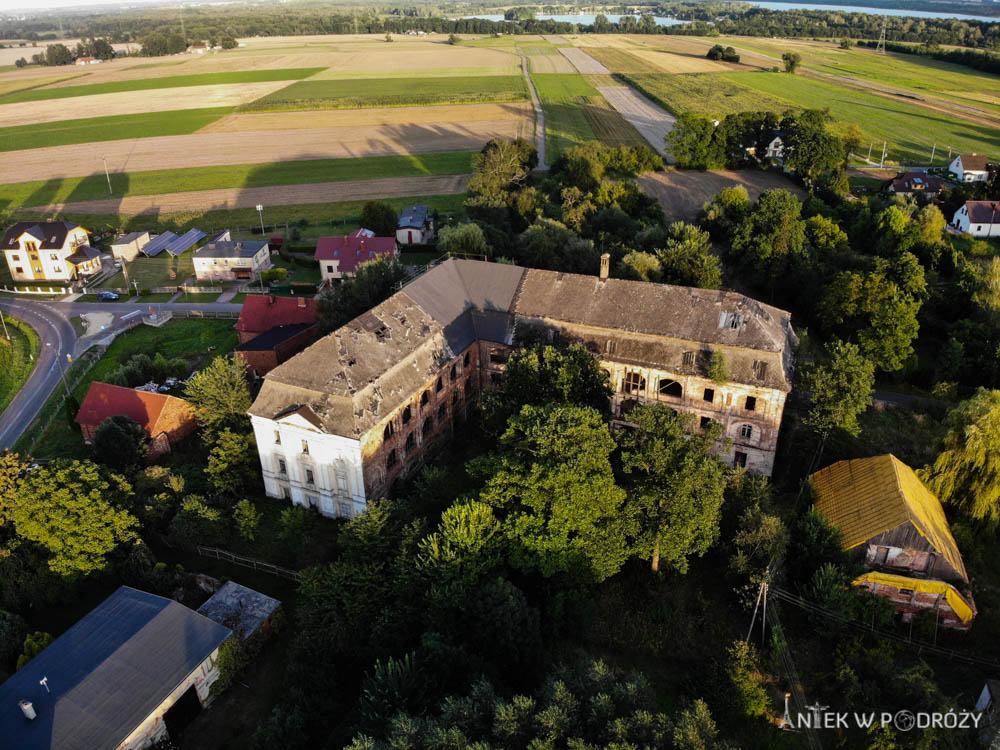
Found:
<box><xmin>76</xmin><ymin>381</ymin><xmax>198</xmax><ymax>457</ymax></box>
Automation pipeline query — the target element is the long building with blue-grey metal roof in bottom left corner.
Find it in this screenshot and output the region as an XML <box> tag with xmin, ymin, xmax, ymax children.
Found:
<box><xmin>0</xmin><ymin>586</ymin><xmax>230</xmax><ymax>750</ymax></box>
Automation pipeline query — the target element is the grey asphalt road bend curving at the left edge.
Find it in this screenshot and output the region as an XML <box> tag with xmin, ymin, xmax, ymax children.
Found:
<box><xmin>0</xmin><ymin>298</ymin><xmax>76</xmax><ymax>450</ymax></box>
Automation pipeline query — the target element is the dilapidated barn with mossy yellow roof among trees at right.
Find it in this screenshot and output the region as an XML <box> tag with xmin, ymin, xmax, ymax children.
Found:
<box><xmin>809</xmin><ymin>454</ymin><xmax>976</xmax><ymax>629</ymax></box>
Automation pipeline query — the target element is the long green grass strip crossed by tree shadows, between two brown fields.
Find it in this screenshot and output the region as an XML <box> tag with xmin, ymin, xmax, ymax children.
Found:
<box><xmin>3</xmin><ymin>151</ymin><xmax>473</xmax><ymax>209</ymax></box>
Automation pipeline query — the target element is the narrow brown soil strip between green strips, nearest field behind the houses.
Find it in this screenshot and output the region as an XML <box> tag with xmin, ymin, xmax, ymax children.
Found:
<box><xmin>25</xmin><ymin>175</ymin><xmax>469</xmax><ymax>216</ymax></box>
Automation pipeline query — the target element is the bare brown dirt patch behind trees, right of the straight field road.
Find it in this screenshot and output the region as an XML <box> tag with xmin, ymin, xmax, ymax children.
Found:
<box><xmin>638</xmin><ymin>169</ymin><xmax>805</xmax><ymax>221</ymax></box>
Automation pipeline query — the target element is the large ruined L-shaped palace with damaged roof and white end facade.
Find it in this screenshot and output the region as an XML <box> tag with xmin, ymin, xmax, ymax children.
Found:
<box><xmin>250</xmin><ymin>259</ymin><xmax>797</xmax><ymax>517</ymax></box>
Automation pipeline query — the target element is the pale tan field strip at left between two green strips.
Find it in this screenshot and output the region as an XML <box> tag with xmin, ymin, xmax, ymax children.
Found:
<box><xmin>0</xmin><ymin>81</ymin><xmax>288</xmax><ymax>127</ymax></box>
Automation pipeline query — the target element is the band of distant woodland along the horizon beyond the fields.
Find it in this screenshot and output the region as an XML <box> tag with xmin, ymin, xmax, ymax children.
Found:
<box><xmin>0</xmin><ymin>0</ymin><xmax>1000</xmax><ymax>49</ymax></box>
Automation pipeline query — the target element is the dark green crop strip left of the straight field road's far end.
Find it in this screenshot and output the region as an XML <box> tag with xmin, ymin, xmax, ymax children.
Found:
<box><xmin>239</xmin><ymin>76</ymin><xmax>528</xmax><ymax>112</ymax></box>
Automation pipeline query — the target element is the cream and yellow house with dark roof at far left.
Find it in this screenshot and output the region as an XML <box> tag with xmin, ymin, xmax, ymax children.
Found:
<box><xmin>0</xmin><ymin>221</ymin><xmax>101</xmax><ymax>281</ymax></box>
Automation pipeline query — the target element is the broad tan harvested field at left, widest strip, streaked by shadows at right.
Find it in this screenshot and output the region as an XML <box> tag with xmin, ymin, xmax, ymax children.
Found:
<box><xmin>0</xmin><ymin>119</ymin><xmax>532</xmax><ymax>184</ymax></box>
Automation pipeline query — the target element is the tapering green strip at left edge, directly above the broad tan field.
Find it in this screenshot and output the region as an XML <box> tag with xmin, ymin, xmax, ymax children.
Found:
<box><xmin>0</xmin><ymin>106</ymin><xmax>233</xmax><ymax>152</ymax></box>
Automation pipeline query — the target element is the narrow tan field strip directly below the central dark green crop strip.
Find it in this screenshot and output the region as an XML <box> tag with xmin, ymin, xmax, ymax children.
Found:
<box><xmin>198</xmin><ymin>102</ymin><xmax>534</xmax><ymax>133</ymax></box>
